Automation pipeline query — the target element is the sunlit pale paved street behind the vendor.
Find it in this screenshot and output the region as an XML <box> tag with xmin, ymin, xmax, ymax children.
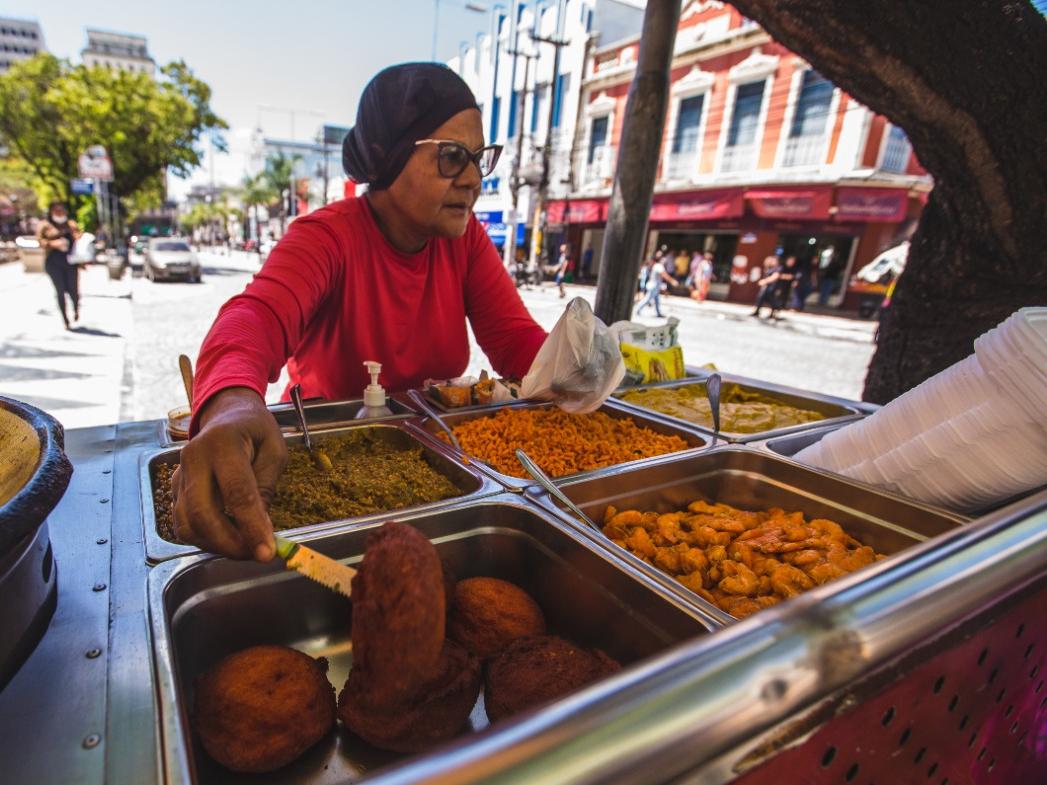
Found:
<box><xmin>0</xmin><ymin>252</ymin><xmax>874</xmax><ymax>428</ymax></box>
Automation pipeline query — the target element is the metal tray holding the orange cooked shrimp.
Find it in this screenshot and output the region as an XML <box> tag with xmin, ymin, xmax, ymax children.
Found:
<box><xmin>526</xmin><ymin>446</ymin><xmax>965</xmax><ymax>620</ymax></box>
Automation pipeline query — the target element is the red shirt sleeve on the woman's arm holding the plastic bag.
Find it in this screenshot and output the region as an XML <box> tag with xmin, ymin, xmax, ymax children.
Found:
<box><xmin>465</xmin><ymin>219</ymin><xmax>547</xmax><ymax>379</ymax></box>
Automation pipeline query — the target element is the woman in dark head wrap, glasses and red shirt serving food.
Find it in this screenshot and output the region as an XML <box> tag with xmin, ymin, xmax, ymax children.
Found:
<box><xmin>174</xmin><ymin>63</ymin><xmax>547</xmax><ymax>561</ymax></box>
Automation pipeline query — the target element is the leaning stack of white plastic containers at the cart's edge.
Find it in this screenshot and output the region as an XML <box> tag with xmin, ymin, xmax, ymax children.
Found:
<box><xmin>795</xmin><ymin>308</ymin><xmax>1047</xmax><ymax>512</ymax></box>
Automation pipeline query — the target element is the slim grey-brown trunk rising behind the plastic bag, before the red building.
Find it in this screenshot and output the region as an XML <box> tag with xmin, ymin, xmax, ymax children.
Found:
<box><xmin>596</xmin><ymin>0</ymin><xmax>680</xmax><ymax>324</ymax></box>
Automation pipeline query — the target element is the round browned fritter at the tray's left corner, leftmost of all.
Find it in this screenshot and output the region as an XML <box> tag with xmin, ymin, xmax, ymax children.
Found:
<box><xmin>193</xmin><ymin>646</ymin><xmax>335</xmax><ymax>772</ymax></box>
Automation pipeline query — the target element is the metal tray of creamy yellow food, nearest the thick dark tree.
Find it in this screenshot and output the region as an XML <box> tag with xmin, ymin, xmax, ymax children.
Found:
<box><xmin>614</xmin><ymin>372</ymin><xmax>867</xmax><ymax>444</ymax></box>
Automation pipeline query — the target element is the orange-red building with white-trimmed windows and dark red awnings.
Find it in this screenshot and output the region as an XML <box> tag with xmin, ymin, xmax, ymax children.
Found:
<box><xmin>547</xmin><ymin>0</ymin><xmax>931</xmax><ymax>308</ymax></box>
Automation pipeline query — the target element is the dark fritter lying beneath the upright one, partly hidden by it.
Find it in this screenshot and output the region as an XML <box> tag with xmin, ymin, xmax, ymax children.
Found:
<box><xmin>338</xmin><ymin>641</ymin><xmax>482</xmax><ymax>753</ymax></box>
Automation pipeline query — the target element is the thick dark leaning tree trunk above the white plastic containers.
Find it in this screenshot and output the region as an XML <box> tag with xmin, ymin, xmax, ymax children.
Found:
<box><xmin>731</xmin><ymin>0</ymin><xmax>1047</xmax><ymax>403</ymax></box>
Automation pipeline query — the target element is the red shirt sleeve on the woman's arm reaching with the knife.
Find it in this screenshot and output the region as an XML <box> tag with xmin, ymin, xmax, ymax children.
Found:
<box><xmin>190</xmin><ymin>218</ymin><xmax>340</xmax><ymax>433</ymax></box>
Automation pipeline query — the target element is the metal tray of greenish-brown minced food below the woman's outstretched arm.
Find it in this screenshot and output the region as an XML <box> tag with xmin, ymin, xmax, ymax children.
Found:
<box><xmin>139</xmin><ymin>418</ymin><xmax>502</xmax><ymax>563</ymax></box>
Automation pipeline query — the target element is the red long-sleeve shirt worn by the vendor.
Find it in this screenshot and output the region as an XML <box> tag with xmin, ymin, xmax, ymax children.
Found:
<box><xmin>193</xmin><ymin>198</ymin><xmax>545</xmax><ymax>432</ymax></box>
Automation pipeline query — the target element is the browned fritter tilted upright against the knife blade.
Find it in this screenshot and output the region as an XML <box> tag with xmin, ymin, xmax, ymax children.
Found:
<box><xmin>352</xmin><ymin>521</ymin><xmax>446</xmax><ymax>708</ymax></box>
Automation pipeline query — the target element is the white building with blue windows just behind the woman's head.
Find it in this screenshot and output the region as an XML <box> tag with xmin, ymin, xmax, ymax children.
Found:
<box><xmin>448</xmin><ymin>0</ymin><xmax>643</xmax><ymax>264</ymax></box>
